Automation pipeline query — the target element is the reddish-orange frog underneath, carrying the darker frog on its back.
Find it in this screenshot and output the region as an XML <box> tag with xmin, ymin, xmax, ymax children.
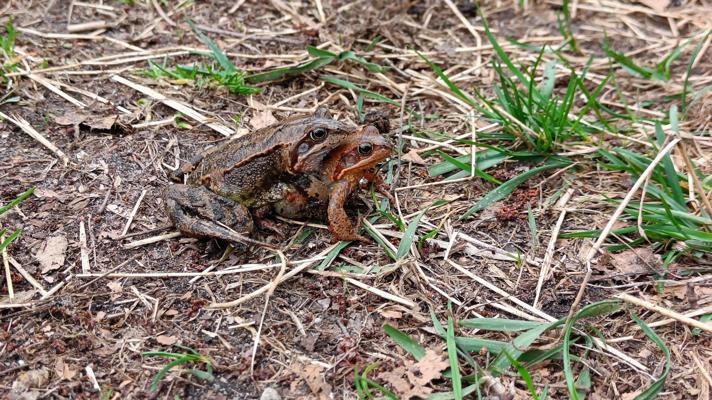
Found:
<box><xmin>274</xmin><ymin>125</ymin><xmax>392</xmax><ymax>241</ymax></box>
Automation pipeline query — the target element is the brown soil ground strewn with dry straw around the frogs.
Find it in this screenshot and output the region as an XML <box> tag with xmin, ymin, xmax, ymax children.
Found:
<box><xmin>0</xmin><ymin>0</ymin><xmax>712</xmax><ymax>399</ymax></box>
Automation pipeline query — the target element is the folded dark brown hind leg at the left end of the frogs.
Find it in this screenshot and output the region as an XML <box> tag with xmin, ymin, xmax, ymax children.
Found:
<box><xmin>163</xmin><ymin>185</ymin><xmax>274</xmax><ymax>248</ymax></box>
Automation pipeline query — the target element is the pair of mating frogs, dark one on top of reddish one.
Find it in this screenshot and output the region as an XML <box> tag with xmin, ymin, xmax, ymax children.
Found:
<box><xmin>164</xmin><ymin>109</ymin><xmax>391</xmax><ymax>247</ymax></box>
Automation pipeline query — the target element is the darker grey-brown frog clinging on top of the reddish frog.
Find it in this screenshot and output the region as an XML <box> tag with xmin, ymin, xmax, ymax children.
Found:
<box><xmin>164</xmin><ymin>108</ymin><xmax>357</xmax><ymax>247</ymax></box>
